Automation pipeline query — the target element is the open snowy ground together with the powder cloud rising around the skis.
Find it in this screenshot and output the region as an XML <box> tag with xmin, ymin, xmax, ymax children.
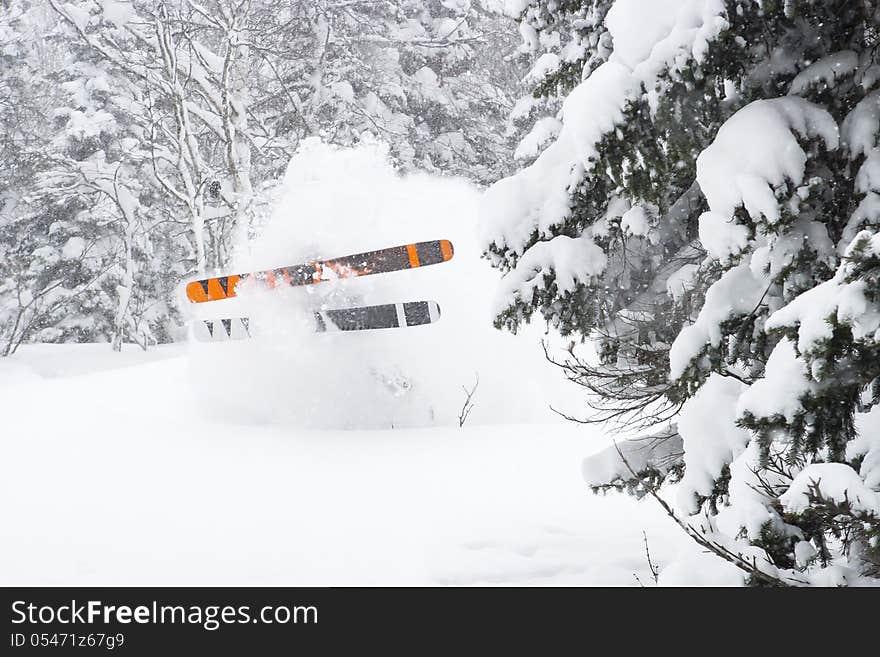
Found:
<box><xmin>0</xmin><ymin>141</ymin><xmax>717</xmax><ymax>585</ymax></box>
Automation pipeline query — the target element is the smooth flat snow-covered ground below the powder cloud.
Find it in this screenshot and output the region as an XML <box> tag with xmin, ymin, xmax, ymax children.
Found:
<box><xmin>0</xmin><ymin>345</ymin><xmax>687</xmax><ymax>585</ymax></box>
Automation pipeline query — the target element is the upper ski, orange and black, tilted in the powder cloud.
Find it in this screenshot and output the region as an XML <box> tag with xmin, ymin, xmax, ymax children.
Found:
<box><xmin>186</xmin><ymin>240</ymin><xmax>453</xmax><ymax>303</ymax></box>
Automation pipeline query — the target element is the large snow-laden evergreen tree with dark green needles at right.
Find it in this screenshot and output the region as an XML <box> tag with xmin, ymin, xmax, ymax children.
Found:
<box><xmin>487</xmin><ymin>0</ymin><xmax>880</xmax><ymax>584</ymax></box>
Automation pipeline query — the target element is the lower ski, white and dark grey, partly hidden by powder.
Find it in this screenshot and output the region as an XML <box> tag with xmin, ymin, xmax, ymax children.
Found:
<box><xmin>193</xmin><ymin>301</ymin><xmax>440</xmax><ymax>342</ymax></box>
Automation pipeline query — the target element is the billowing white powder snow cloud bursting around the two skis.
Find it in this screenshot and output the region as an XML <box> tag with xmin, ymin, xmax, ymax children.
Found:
<box><xmin>190</xmin><ymin>140</ymin><xmax>570</xmax><ymax>429</ymax></box>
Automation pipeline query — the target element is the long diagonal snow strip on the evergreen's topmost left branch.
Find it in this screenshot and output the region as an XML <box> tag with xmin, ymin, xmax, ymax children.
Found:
<box><xmin>483</xmin><ymin>0</ymin><xmax>728</xmax><ymax>255</ymax></box>
